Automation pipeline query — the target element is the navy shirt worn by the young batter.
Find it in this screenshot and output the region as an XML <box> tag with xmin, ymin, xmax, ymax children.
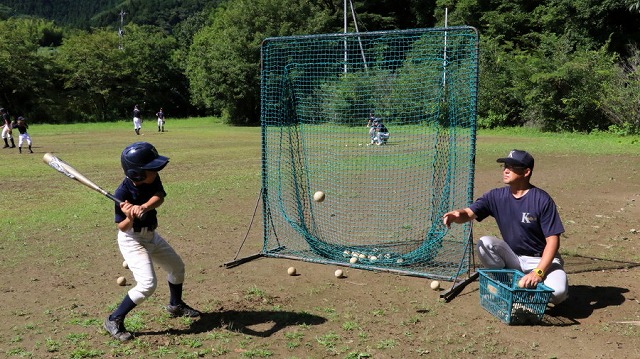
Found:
<box><xmin>113</xmin><ymin>174</ymin><xmax>167</xmax><ymax>227</ymax></box>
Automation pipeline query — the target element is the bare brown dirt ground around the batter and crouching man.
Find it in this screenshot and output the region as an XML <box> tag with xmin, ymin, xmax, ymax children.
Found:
<box><xmin>0</xmin><ymin>139</ymin><xmax>640</xmax><ymax>358</ymax></box>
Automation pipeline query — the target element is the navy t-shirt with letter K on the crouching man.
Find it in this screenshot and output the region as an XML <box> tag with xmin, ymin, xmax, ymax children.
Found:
<box><xmin>469</xmin><ymin>186</ymin><xmax>564</xmax><ymax>256</ymax></box>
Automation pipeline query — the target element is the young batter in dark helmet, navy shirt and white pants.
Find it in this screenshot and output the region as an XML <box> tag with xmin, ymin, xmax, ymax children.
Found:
<box><xmin>104</xmin><ymin>142</ymin><xmax>200</xmax><ymax>341</ymax></box>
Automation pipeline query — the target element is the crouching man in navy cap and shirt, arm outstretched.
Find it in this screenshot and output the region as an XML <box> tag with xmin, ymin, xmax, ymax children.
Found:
<box><xmin>443</xmin><ymin>150</ymin><xmax>569</xmax><ymax>305</ymax></box>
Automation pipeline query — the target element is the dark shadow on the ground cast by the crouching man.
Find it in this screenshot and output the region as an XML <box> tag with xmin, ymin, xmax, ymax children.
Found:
<box><xmin>542</xmin><ymin>285</ymin><xmax>629</xmax><ymax>326</ymax></box>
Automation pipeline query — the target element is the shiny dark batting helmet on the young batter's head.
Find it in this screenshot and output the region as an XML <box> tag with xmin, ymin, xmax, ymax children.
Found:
<box><xmin>120</xmin><ymin>142</ymin><xmax>169</xmax><ymax>182</ymax></box>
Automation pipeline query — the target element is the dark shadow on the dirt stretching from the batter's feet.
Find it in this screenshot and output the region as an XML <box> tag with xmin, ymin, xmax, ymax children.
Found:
<box><xmin>135</xmin><ymin>310</ymin><xmax>327</xmax><ymax>338</ymax></box>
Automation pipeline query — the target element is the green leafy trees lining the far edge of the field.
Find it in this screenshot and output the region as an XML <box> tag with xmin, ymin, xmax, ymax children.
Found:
<box><xmin>0</xmin><ymin>0</ymin><xmax>640</xmax><ymax>134</ymax></box>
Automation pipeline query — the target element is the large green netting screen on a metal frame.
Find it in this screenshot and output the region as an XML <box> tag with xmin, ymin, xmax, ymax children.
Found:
<box><xmin>261</xmin><ymin>27</ymin><xmax>478</xmax><ymax>279</ymax></box>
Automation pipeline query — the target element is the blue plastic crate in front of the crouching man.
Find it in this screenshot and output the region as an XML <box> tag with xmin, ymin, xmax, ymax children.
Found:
<box><xmin>478</xmin><ymin>269</ymin><xmax>553</xmax><ymax>324</ymax></box>
